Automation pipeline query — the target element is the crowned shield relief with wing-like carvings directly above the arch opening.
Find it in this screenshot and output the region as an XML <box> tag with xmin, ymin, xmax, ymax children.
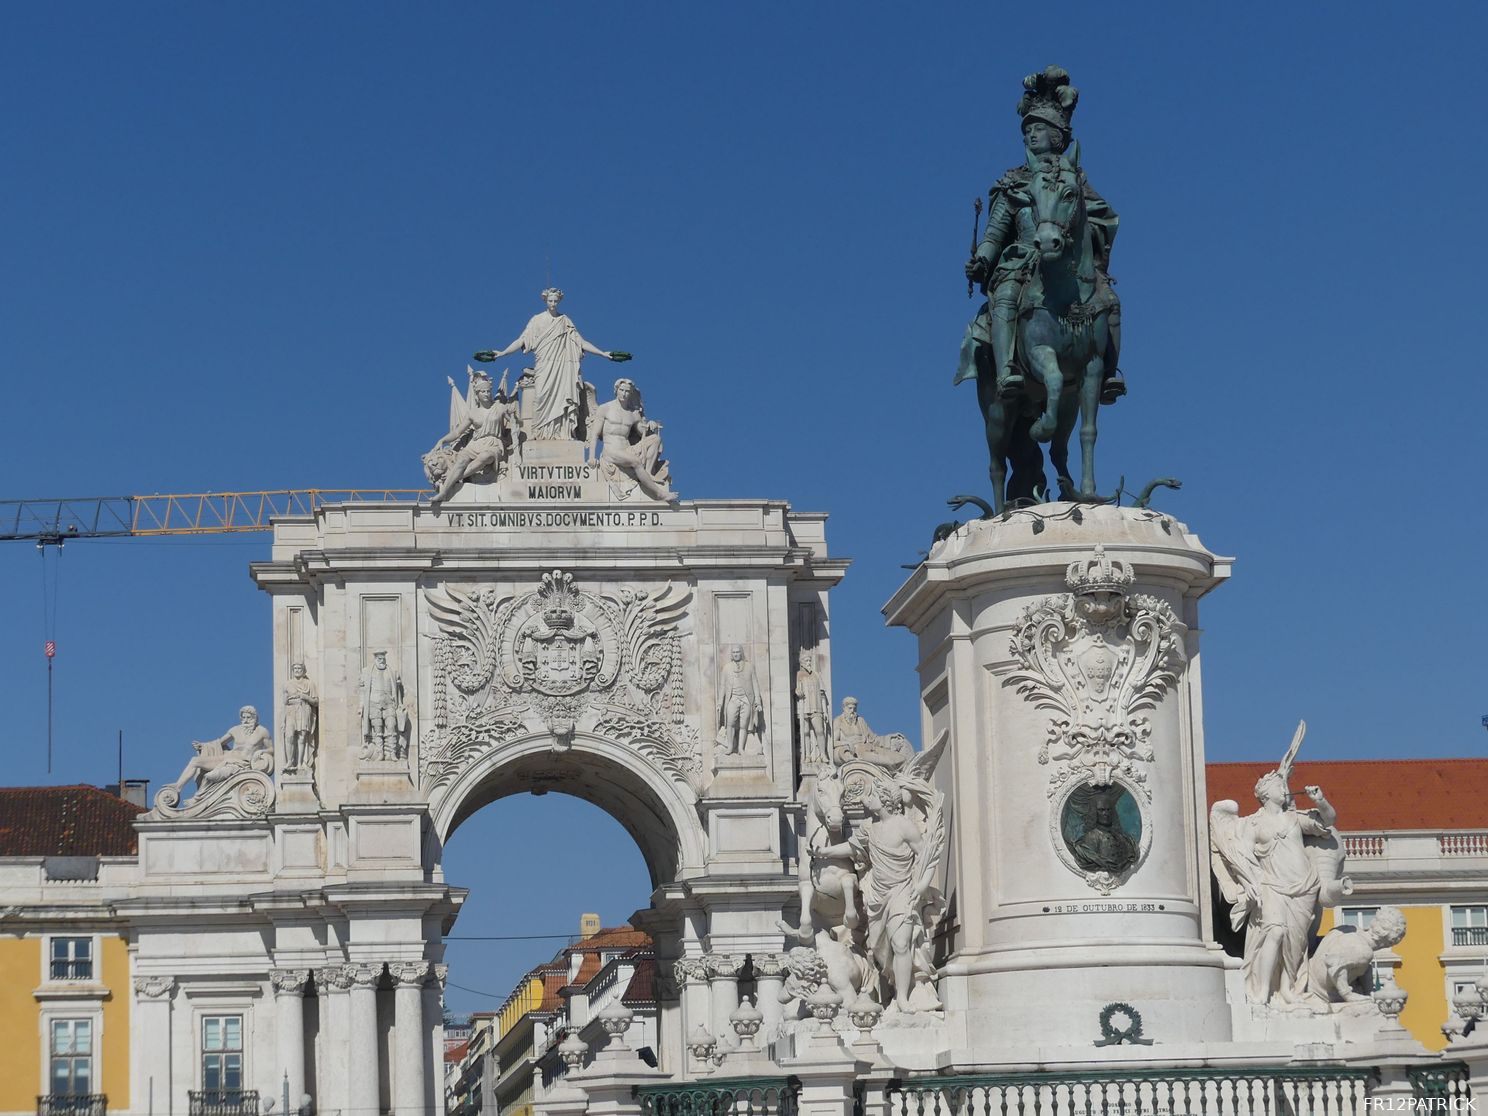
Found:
<box><xmin>420</xmin><ymin>570</ymin><xmax>701</xmax><ymax>795</ymax></box>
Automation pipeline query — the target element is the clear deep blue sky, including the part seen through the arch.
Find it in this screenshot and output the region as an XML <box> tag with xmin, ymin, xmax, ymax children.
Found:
<box><xmin>0</xmin><ymin>3</ymin><xmax>1488</xmax><ymax>1009</ymax></box>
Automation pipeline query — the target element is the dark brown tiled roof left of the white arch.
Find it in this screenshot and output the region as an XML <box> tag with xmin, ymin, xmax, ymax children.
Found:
<box><xmin>0</xmin><ymin>786</ymin><xmax>144</xmax><ymax>857</ymax></box>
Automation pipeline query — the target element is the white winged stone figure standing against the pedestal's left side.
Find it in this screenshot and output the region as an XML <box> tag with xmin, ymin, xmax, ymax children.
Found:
<box><xmin>812</xmin><ymin>740</ymin><xmax>946</xmax><ymax>1012</ymax></box>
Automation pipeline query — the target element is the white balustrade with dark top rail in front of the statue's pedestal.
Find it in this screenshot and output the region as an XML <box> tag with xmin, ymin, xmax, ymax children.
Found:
<box><xmin>887</xmin><ymin>1065</ymin><xmax>1372</xmax><ymax>1116</ymax></box>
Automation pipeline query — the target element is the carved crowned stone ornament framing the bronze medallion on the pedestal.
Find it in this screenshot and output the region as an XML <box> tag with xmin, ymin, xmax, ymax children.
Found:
<box><xmin>1004</xmin><ymin>545</ymin><xmax>1186</xmax><ymax>894</ymax></box>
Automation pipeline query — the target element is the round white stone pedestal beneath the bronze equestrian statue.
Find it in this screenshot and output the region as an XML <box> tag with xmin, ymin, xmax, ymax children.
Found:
<box><xmin>885</xmin><ymin>504</ymin><xmax>1231</xmax><ymax>1065</ymax></box>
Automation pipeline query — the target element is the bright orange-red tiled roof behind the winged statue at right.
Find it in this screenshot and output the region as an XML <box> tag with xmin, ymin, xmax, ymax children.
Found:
<box><xmin>1207</xmin><ymin>759</ymin><xmax>1488</xmax><ymax>833</ymax></box>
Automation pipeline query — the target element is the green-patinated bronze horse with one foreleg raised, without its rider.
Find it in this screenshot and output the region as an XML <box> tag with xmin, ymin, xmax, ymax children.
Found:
<box><xmin>976</xmin><ymin>144</ymin><xmax>1120</xmax><ymax>512</ymax></box>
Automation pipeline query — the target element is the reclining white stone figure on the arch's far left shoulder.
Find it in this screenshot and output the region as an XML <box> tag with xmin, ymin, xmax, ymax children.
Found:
<box><xmin>144</xmin><ymin>705</ymin><xmax>274</xmax><ymax>821</ymax></box>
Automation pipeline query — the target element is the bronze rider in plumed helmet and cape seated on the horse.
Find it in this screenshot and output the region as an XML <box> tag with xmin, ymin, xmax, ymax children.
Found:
<box><xmin>955</xmin><ymin>65</ymin><xmax>1126</xmax><ymax>403</ymax></box>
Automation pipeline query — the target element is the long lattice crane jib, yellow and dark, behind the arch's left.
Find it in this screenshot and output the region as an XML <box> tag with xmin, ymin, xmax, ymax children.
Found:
<box><xmin>0</xmin><ymin>488</ymin><xmax>429</xmax><ymax>548</ymax></box>
